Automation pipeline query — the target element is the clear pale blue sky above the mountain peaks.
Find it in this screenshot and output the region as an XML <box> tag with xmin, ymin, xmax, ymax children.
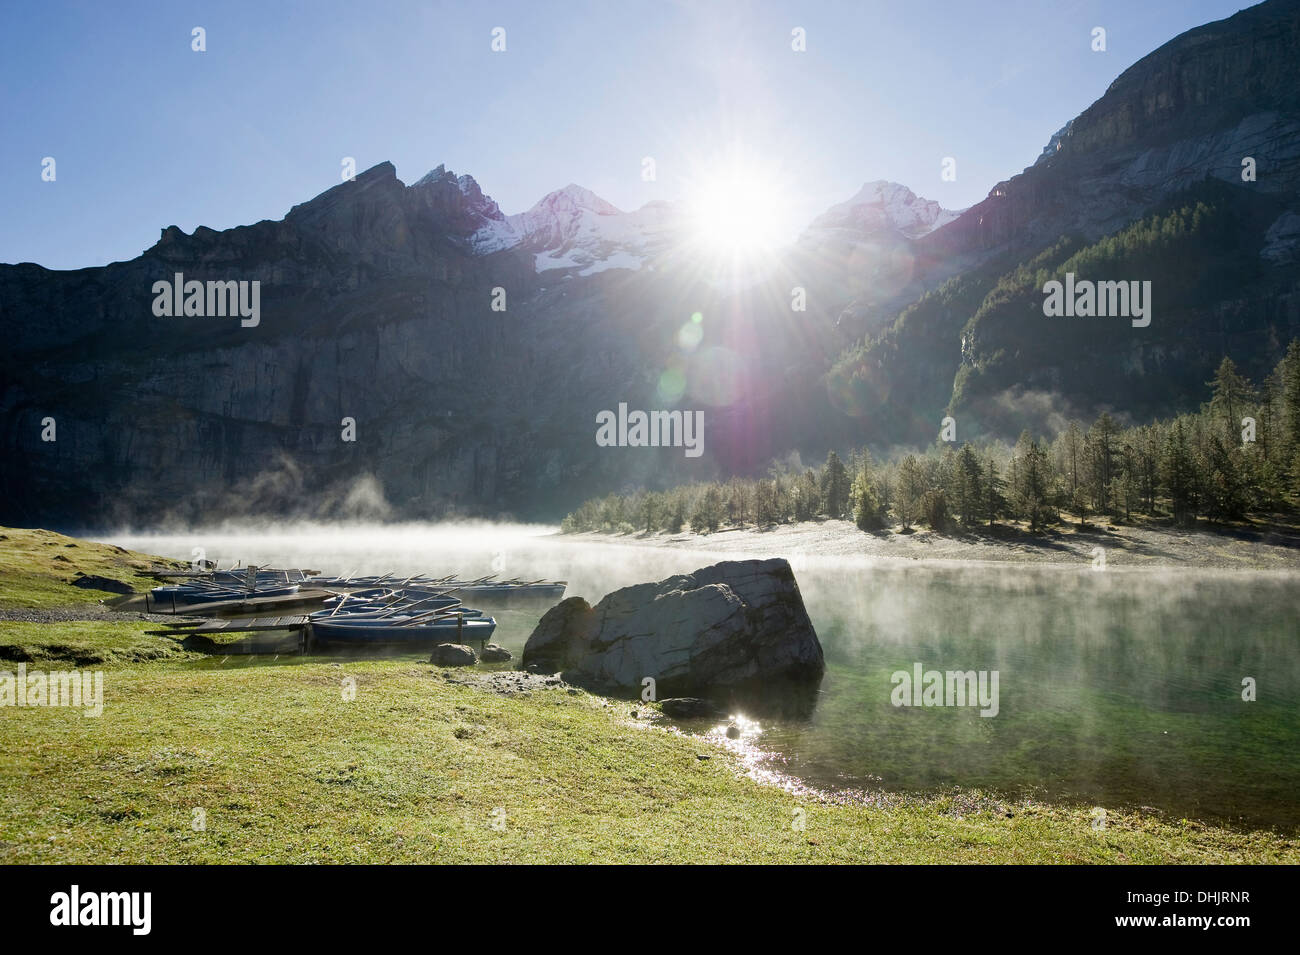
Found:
<box><xmin>0</xmin><ymin>0</ymin><xmax>1244</xmax><ymax>269</ymax></box>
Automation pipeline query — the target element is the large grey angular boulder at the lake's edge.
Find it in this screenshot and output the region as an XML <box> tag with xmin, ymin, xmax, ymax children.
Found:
<box><xmin>521</xmin><ymin>557</ymin><xmax>826</xmax><ymax>698</ymax></box>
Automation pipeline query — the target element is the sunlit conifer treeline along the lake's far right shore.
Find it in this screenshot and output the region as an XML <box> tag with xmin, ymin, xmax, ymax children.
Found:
<box><xmin>562</xmin><ymin>340</ymin><xmax>1300</xmax><ymax>533</ymax></box>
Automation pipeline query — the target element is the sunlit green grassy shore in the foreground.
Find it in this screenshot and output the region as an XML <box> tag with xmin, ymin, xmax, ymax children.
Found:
<box><xmin>0</xmin><ymin>529</ymin><xmax>1300</xmax><ymax>863</ymax></box>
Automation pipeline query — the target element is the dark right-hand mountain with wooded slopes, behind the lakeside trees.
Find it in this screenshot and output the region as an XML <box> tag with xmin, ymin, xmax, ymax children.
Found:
<box><xmin>832</xmin><ymin>0</ymin><xmax>1300</xmax><ymax>440</ymax></box>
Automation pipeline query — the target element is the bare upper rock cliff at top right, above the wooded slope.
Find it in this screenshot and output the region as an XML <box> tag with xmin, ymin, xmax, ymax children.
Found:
<box><xmin>922</xmin><ymin>0</ymin><xmax>1300</xmax><ymax>261</ymax></box>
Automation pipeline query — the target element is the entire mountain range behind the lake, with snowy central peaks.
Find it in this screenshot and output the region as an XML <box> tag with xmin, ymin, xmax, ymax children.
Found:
<box><xmin>0</xmin><ymin>0</ymin><xmax>1300</xmax><ymax>525</ymax></box>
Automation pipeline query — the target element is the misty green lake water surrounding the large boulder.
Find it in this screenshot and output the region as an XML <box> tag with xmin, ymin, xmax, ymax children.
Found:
<box><xmin>105</xmin><ymin>524</ymin><xmax>1300</xmax><ymax>828</ymax></box>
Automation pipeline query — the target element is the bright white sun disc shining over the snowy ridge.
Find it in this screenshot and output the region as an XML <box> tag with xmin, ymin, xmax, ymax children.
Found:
<box><xmin>689</xmin><ymin>161</ymin><xmax>789</xmax><ymax>260</ymax></box>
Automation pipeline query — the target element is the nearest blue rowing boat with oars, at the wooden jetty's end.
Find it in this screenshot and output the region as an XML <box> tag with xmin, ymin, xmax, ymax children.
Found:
<box><xmin>309</xmin><ymin>583</ymin><xmax>497</xmax><ymax>646</ymax></box>
